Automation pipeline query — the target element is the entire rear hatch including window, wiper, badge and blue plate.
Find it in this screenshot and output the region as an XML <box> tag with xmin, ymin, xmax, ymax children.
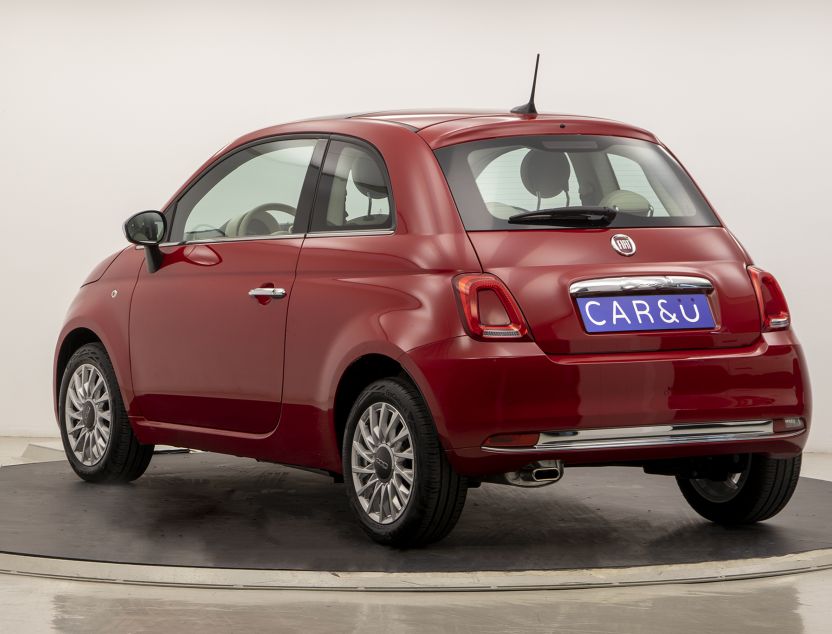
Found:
<box><xmin>436</xmin><ymin>131</ymin><xmax>761</xmax><ymax>354</ymax></box>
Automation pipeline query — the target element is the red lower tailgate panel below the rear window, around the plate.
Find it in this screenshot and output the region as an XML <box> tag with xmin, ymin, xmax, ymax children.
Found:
<box><xmin>468</xmin><ymin>227</ymin><xmax>760</xmax><ymax>354</ymax></box>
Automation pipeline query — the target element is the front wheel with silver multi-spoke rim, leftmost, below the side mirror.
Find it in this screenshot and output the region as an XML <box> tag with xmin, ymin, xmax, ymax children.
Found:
<box><xmin>58</xmin><ymin>343</ymin><xmax>153</xmax><ymax>482</ymax></box>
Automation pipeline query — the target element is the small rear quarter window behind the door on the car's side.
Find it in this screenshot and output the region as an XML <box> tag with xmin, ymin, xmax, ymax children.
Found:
<box><xmin>312</xmin><ymin>140</ymin><xmax>393</xmax><ymax>232</ymax></box>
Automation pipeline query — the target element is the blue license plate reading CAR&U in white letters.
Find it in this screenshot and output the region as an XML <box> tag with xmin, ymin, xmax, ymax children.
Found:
<box><xmin>578</xmin><ymin>293</ymin><xmax>714</xmax><ymax>332</ymax></box>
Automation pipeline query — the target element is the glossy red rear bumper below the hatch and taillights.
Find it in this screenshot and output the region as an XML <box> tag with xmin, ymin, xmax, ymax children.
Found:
<box><xmin>405</xmin><ymin>331</ymin><xmax>811</xmax><ymax>475</ymax></box>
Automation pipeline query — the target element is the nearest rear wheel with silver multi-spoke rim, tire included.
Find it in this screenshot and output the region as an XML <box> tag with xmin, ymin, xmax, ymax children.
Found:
<box><xmin>342</xmin><ymin>378</ymin><xmax>468</xmax><ymax>548</ymax></box>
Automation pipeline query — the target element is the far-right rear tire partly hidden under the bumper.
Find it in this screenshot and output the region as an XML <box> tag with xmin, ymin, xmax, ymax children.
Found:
<box><xmin>676</xmin><ymin>454</ymin><xmax>802</xmax><ymax>526</ymax></box>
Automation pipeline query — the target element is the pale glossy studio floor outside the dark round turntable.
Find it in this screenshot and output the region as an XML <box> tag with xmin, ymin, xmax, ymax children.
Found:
<box><xmin>0</xmin><ymin>438</ymin><xmax>832</xmax><ymax>634</ymax></box>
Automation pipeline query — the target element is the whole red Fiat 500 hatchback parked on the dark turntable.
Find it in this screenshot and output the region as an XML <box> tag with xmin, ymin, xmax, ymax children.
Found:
<box><xmin>54</xmin><ymin>107</ymin><xmax>810</xmax><ymax>546</ymax></box>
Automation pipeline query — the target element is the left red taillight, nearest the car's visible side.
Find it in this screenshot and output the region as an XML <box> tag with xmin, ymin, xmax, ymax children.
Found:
<box><xmin>454</xmin><ymin>273</ymin><xmax>529</xmax><ymax>341</ymax></box>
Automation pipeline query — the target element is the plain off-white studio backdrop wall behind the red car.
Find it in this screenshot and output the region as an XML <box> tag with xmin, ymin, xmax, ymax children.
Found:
<box><xmin>0</xmin><ymin>0</ymin><xmax>832</xmax><ymax>450</ymax></box>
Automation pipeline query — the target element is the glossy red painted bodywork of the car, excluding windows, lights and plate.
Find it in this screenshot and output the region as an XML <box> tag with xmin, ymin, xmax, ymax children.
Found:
<box><xmin>56</xmin><ymin>113</ymin><xmax>811</xmax><ymax>474</ymax></box>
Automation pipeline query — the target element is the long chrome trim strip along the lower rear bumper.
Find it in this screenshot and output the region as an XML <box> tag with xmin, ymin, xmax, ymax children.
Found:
<box><xmin>482</xmin><ymin>420</ymin><xmax>780</xmax><ymax>453</ymax></box>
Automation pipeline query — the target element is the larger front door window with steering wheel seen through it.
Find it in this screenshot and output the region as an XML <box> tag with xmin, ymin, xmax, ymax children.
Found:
<box><xmin>170</xmin><ymin>139</ymin><xmax>318</xmax><ymax>242</ymax></box>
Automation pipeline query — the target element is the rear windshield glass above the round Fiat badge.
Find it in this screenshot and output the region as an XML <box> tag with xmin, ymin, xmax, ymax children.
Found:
<box><xmin>436</xmin><ymin>135</ymin><xmax>719</xmax><ymax>231</ymax></box>
